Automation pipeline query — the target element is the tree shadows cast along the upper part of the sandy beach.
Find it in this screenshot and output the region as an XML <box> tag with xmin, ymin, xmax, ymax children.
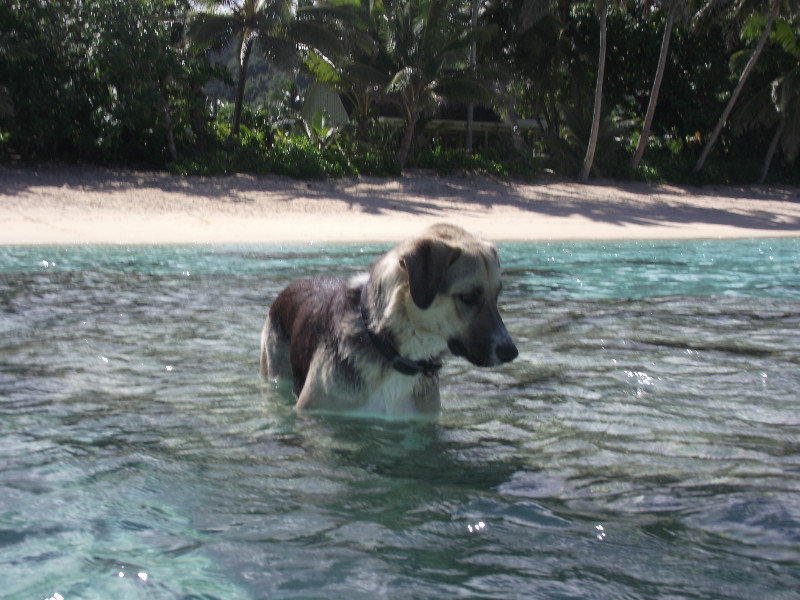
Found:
<box><xmin>0</xmin><ymin>167</ymin><xmax>800</xmax><ymax>233</ymax></box>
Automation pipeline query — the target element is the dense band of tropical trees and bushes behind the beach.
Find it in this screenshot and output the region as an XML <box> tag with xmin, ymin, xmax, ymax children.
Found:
<box><xmin>0</xmin><ymin>0</ymin><xmax>800</xmax><ymax>183</ymax></box>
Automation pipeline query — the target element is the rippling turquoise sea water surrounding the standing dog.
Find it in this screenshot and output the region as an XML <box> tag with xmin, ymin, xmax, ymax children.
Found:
<box><xmin>0</xmin><ymin>239</ymin><xmax>800</xmax><ymax>600</ymax></box>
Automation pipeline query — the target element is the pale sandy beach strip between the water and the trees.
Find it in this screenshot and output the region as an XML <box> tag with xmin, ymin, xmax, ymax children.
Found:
<box><xmin>0</xmin><ymin>166</ymin><xmax>800</xmax><ymax>245</ymax></box>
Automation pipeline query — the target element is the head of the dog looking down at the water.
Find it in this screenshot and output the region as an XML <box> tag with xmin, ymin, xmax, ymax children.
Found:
<box><xmin>399</xmin><ymin>225</ymin><xmax>518</xmax><ymax>367</ymax></box>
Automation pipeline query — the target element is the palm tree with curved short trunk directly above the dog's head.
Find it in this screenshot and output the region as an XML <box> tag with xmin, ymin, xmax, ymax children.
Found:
<box><xmin>378</xmin><ymin>0</ymin><xmax>491</xmax><ymax>169</ymax></box>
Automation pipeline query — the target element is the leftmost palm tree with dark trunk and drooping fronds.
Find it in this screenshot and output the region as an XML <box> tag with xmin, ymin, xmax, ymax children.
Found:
<box><xmin>188</xmin><ymin>0</ymin><xmax>337</xmax><ymax>136</ymax></box>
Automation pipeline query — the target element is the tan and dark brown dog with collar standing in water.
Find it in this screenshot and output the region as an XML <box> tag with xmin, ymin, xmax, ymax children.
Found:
<box><xmin>260</xmin><ymin>224</ymin><xmax>518</xmax><ymax>415</ymax></box>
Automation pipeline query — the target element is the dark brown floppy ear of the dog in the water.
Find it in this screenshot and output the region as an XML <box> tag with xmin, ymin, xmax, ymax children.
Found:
<box><xmin>400</xmin><ymin>240</ymin><xmax>461</xmax><ymax>310</ymax></box>
